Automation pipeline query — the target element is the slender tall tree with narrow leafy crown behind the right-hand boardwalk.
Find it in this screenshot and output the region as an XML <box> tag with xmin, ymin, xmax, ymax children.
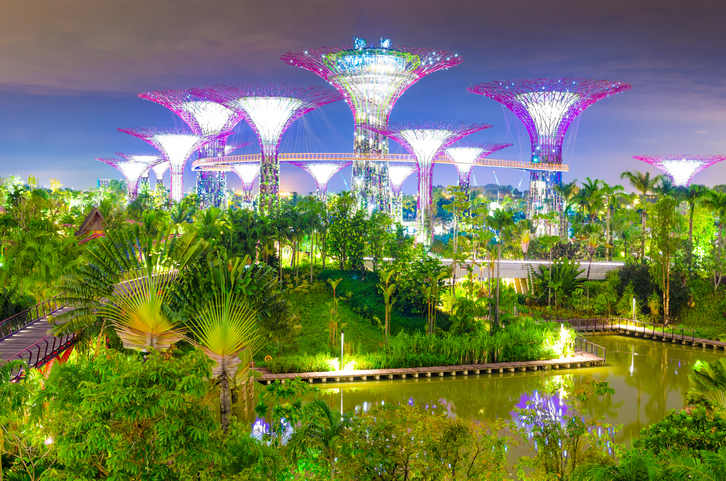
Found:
<box><xmin>650</xmin><ymin>195</ymin><xmax>680</xmax><ymax>325</ymax></box>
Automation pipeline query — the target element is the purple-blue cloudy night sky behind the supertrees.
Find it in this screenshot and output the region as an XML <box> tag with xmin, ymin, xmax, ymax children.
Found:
<box><xmin>0</xmin><ymin>0</ymin><xmax>726</xmax><ymax>192</ymax></box>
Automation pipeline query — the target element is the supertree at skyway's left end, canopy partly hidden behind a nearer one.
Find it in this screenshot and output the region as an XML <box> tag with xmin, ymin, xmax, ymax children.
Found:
<box><xmin>139</xmin><ymin>89</ymin><xmax>247</xmax><ymax>207</ymax></box>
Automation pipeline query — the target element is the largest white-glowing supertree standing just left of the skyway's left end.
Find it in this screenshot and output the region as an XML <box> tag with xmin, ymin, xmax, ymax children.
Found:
<box><xmin>118</xmin><ymin>128</ymin><xmax>209</xmax><ymax>202</ymax></box>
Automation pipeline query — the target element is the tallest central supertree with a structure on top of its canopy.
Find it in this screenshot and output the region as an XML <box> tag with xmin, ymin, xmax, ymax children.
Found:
<box><xmin>281</xmin><ymin>38</ymin><xmax>461</xmax><ymax>212</ymax></box>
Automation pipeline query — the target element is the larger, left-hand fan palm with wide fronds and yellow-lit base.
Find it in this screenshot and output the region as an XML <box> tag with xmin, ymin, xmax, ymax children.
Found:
<box><xmin>53</xmin><ymin>225</ymin><xmax>206</xmax><ymax>351</ymax></box>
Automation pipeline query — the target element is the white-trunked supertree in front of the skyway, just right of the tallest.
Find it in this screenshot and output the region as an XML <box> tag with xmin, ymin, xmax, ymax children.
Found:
<box><xmin>379</xmin><ymin>122</ymin><xmax>491</xmax><ymax>245</ymax></box>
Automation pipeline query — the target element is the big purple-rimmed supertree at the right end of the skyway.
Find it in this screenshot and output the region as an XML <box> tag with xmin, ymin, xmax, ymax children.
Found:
<box><xmin>467</xmin><ymin>78</ymin><xmax>630</xmax><ymax>218</ymax></box>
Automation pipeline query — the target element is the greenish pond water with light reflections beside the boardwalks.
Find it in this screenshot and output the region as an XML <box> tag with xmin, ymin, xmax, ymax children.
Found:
<box><xmin>320</xmin><ymin>336</ymin><xmax>724</xmax><ymax>444</ymax></box>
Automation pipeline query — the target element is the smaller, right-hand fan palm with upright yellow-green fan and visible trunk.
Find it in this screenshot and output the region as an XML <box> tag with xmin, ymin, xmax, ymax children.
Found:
<box><xmin>187</xmin><ymin>288</ymin><xmax>262</xmax><ymax>433</ymax></box>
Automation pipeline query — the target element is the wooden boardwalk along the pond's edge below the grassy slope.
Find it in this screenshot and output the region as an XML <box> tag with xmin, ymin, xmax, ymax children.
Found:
<box><xmin>255</xmin><ymin>349</ymin><xmax>605</xmax><ymax>384</ymax></box>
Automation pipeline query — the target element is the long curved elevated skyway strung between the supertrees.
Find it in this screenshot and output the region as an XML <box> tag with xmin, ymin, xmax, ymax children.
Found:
<box><xmin>192</xmin><ymin>152</ymin><xmax>570</xmax><ymax>172</ymax></box>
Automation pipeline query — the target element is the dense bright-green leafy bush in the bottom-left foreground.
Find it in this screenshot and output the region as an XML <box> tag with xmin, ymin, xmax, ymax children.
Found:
<box><xmin>36</xmin><ymin>351</ymin><xmax>233</xmax><ymax>480</ymax></box>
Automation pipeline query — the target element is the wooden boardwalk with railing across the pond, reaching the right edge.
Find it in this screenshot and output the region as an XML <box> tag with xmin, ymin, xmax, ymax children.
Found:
<box><xmin>550</xmin><ymin>319</ymin><xmax>726</xmax><ymax>350</ymax></box>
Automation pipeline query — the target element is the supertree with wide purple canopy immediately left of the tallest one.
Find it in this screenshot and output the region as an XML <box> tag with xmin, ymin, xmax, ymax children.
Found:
<box><xmin>193</xmin><ymin>85</ymin><xmax>342</xmax><ymax>212</ymax></box>
